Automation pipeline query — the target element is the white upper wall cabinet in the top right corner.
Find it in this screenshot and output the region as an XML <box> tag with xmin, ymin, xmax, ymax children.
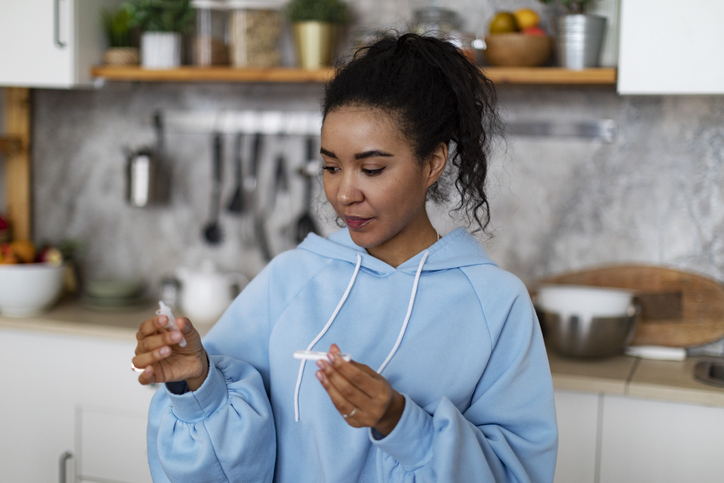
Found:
<box><xmin>618</xmin><ymin>0</ymin><xmax>724</xmax><ymax>94</ymax></box>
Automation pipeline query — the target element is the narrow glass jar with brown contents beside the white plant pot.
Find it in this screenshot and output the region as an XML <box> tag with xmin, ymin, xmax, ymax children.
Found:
<box><xmin>191</xmin><ymin>0</ymin><xmax>229</xmax><ymax>66</ymax></box>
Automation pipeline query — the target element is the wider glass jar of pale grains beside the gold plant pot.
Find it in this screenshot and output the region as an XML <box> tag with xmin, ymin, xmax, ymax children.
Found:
<box><xmin>229</xmin><ymin>0</ymin><xmax>283</xmax><ymax>67</ymax></box>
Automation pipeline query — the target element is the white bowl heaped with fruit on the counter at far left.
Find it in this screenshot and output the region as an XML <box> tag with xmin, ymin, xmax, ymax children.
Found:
<box><xmin>0</xmin><ymin>240</ymin><xmax>65</xmax><ymax>317</ymax></box>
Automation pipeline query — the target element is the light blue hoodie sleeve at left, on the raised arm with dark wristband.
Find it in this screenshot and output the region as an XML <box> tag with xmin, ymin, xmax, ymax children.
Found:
<box><xmin>147</xmin><ymin>267</ymin><xmax>276</xmax><ymax>482</ymax></box>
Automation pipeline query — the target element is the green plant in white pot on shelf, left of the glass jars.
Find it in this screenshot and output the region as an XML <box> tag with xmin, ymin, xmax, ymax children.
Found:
<box><xmin>125</xmin><ymin>0</ymin><xmax>194</xmax><ymax>69</ymax></box>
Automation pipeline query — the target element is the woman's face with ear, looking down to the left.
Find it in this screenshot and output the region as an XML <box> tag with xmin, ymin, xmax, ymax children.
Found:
<box><xmin>321</xmin><ymin>107</ymin><xmax>447</xmax><ymax>259</ymax></box>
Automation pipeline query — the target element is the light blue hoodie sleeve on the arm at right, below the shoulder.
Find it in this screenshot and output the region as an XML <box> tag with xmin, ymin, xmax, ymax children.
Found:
<box><xmin>371</xmin><ymin>272</ymin><xmax>558</xmax><ymax>482</ymax></box>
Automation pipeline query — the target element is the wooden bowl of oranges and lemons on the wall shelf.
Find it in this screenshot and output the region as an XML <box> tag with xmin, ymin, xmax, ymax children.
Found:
<box><xmin>484</xmin><ymin>9</ymin><xmax>552</xmax><ymax>67</ymax></box>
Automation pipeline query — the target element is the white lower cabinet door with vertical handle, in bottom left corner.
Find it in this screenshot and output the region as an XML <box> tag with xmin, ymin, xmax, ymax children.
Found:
<box><xmin>0</xmin><ymin>328</ymin><xmax>79</xmax><ymax>482</ymax></box>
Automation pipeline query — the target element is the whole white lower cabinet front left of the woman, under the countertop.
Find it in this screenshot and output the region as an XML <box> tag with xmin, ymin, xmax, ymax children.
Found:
<box><xmin>0</xmin><ymin>329</ymin><xmax>154</xmax><ymax>483</ymax></box>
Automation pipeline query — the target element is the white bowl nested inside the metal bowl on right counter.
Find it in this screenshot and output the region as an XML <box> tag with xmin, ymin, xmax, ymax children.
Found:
<box><xmin>536</xmin><ymin>284</ymin><xmax>635</xmax><ymax>320</ymax></box>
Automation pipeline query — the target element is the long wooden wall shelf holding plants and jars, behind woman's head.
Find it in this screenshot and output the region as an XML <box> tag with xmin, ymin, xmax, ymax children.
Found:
<box><xmin>91</xmin><ymin>66</ymin><xmax>616</xmax><ymax>86</ymax></box>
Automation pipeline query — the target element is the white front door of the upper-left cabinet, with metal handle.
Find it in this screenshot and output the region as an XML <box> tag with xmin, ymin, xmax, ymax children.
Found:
<box><xmin>0</xmin><ymin>0</ymin><xmax>75</xmax><ymax>87</ymax></box>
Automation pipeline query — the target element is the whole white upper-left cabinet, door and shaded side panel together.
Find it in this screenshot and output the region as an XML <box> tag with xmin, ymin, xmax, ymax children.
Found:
<box><xmin>0</xmin><ymin>0</ymin><xmax>120</xmax><ymax>88</ymax></box>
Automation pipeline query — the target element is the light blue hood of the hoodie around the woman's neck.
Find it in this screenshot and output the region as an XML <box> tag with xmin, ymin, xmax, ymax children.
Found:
<box><xmin>299</xmin><ymin>228</ymin><xmax>497</xmax><ymax>277</ymax></box>
